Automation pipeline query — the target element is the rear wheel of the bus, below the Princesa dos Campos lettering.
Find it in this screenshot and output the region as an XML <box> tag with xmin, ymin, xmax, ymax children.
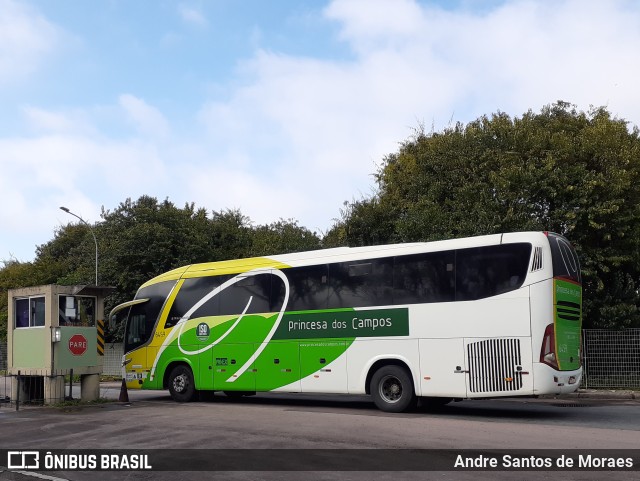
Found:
<box><xmin>369</xmin><ymin>365</ymin><xmax>417</xmax><ymax>413</ymax></box>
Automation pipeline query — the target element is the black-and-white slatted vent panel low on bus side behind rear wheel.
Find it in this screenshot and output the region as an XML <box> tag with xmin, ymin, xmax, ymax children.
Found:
<box><xmin>467</xmin><ymin>339</ymin><xmax>522</xmax><ymax>392</ymax></box>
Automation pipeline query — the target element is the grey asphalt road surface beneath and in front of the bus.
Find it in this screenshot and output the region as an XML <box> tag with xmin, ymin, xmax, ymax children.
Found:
<box><xmin>0</xmin><ymin>384</ymin><xmax>640</xmax><ymax>481</ymax></box>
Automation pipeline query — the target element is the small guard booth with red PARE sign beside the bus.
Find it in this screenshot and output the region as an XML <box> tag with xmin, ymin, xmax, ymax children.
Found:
<box><xmin>7</xmin><ymin>285</ymin><xmax>113</xmax><ymax>404</ymax></box>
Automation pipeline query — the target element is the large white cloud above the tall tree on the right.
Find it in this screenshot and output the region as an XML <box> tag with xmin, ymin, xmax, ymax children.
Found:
<box><xmin>325</xmin><ymin>0</ymin><xmax>640</xmax><ymax>124</ymax></box>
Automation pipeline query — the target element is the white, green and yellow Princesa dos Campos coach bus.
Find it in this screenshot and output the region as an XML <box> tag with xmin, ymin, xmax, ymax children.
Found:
<box><xmin>112</xmin><ymin>232</ymin><xmax>582</xmax><ymax>412</ymax></box>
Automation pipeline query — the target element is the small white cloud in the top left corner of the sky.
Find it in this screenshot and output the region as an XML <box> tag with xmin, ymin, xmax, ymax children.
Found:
<box><xmin>0</xmin><ymin>0</ymin><xmax>63</xmax><ymax>85</ymax></box>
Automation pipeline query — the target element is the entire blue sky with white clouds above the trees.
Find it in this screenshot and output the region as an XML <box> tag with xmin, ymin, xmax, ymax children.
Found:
<box><xmin>0</xmin><ymin>0</ymin><xmax>640</xmax><ymax>266</ymax></box>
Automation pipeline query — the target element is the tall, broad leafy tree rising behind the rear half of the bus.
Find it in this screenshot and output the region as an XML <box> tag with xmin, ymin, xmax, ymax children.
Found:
<box><xmin>334</xmin><ymin>102</ymin><xmax>640</xmax><ymax>327</ymax></box>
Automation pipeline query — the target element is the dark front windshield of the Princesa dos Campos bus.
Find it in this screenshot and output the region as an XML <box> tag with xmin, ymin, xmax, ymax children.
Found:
<box><xmin>124</xmin><ymin>281</ymin><xmax>176</xmax><ymax>353</ymax></box>
